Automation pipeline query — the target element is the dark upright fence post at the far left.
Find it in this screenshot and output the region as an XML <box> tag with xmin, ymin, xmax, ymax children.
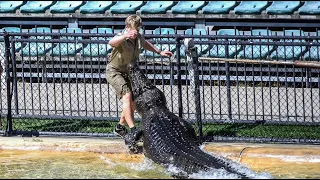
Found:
<box><xmin>4</xmin><ymin>32</ymin><xmax>12</xmax><ymax>136</ymax></box>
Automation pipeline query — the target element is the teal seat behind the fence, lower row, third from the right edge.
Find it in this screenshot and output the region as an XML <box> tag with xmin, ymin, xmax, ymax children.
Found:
<box><xmin>237</xmin><ymin>29</ymin><xmax>275</xmax><ymax>59</ymax></box>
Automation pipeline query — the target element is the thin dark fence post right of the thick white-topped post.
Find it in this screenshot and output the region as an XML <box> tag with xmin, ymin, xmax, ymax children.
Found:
<box><xmin>225</xmin><ymin>38</ymin><xmax>232</xmax><ymax>120</ymax></box>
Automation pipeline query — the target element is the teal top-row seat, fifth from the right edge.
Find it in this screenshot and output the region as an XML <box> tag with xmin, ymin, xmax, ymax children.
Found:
<box><xmin>171</xmin><ymin>1</ymin><xmax>205</xmax><ymax>14</ymax></box>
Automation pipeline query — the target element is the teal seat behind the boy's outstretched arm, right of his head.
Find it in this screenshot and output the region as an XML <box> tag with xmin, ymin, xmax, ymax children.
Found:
<box><xmin>145</xmin><ymin>28</ymin><xmax>176</xmax><ymax>57</ymax></box>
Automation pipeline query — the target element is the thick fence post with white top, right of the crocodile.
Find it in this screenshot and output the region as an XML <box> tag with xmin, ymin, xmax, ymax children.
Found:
<box><xmin>184</xmin><ymin>38</ymin><xmax>203</xmax><ymax>139</ymax></box>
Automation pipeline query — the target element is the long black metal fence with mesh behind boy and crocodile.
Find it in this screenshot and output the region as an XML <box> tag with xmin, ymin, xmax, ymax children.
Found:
<box><xmin>0</xmin><ymin>29</ymin><xmax>320</xmax><ymax>143</ymax></box>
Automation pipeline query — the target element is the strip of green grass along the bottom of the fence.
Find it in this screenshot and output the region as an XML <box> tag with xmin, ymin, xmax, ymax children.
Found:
<box><xmin>2</xmin><ymin>119</ymin><xmax>320</xmax><ymax>139</ymax></box>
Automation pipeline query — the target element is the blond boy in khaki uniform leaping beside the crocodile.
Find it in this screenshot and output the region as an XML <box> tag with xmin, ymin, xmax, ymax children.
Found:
<box><xmin>106</xmin><ymin>15</ymin><xmax>173</xmax><ymax>145</ymax></box>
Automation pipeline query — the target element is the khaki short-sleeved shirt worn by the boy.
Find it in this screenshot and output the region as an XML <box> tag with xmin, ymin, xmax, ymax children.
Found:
<box><xmin>107</xmin><ymin>33</ymin><xmax>145</xmax><ymax>73</ymax></box>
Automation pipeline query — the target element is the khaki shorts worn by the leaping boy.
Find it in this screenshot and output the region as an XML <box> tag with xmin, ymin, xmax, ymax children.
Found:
<box><xmin>106</xmin><ymin>68</ymin><xmax>131</xmax><ymax>99</ymax></box>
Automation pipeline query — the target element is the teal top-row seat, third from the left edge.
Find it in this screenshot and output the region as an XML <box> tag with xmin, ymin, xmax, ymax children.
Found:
<box><xmin>50</xmin><ymin>1</ymin><xmax>83</xmax><ymax>13</ymax></box>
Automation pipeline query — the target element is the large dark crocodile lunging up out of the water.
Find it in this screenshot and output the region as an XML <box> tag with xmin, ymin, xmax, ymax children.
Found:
<box><xmin>128</xmin><ymin>63</ymin><xmax>270</xmax><ymax>178</ymax></box>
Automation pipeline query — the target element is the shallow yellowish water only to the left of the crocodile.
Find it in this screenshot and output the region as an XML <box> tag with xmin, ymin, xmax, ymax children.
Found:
<box><xmin>0</xmin><ymin>150</ymin><xmax>170</xmax><ymax>179</ymax></box>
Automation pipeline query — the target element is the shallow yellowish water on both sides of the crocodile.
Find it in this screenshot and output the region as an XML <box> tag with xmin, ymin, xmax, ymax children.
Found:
<box><xmin>0</xmin><ymin>150</ymin><xmax>320</xmax><ymax>179</ymax></box>
